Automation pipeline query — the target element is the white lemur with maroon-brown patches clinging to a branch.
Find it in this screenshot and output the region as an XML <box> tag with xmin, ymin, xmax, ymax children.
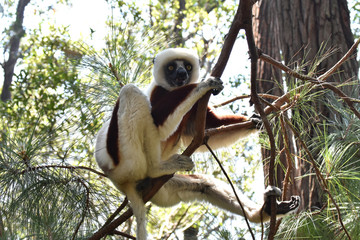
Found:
<box><xmin>95</xmin><ymin>48</ymin><xmax>300</xmax><ymax>240</ymax></box>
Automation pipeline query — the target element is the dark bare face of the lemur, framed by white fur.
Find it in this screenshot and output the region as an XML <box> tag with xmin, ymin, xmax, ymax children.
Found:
<box><xmin>164</xmin><ymin>59</ymin><xmax>193</xmax><ymax>87</ymax></box>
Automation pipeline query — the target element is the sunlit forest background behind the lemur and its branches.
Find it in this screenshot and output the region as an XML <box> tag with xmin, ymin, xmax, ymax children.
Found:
<box><xmin>0</xmin><ymin>0</ymin><xmax>360</xmax><ymax>239</ymax></box>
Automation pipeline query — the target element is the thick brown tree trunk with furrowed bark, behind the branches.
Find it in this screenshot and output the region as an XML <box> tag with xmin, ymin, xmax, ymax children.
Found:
<box><xmin>254</xmin><ymin>0</ymin><xmax>358</xmax><ymax>209</ymax></box>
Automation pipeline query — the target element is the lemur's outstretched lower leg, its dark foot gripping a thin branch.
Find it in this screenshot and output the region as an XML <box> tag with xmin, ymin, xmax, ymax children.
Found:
<box><xmin>151</xmin><ymin>175</ymin><xmax>300</xmax><ymax>222</ymax></box>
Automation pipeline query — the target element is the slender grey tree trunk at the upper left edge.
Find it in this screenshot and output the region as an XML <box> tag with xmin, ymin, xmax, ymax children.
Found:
<box><xmin>1</xmin><ymin>0</ymin><xmax>30</xmax><ymax>102</ymax></box>
